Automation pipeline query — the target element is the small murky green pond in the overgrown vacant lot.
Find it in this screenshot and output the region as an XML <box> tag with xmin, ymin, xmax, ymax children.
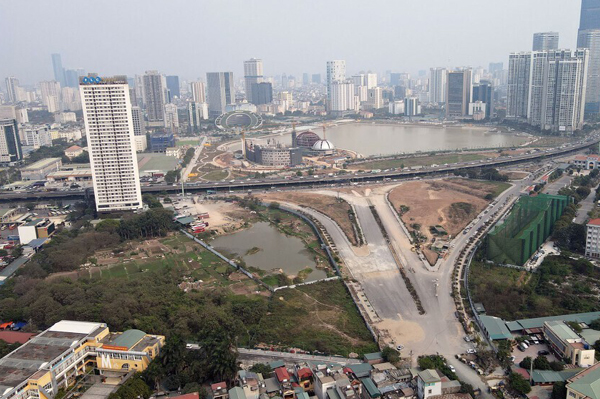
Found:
<box><xmin>211</xmin><ymin>222</ymin><xmax>327</xmax><ymax>281</ymax></box>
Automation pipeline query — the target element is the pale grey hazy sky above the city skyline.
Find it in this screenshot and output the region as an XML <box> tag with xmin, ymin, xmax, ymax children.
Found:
<box><xmin>0</xmin><ymin>0</ymin><xmax>581</xmax><ymax>84</ymax></box>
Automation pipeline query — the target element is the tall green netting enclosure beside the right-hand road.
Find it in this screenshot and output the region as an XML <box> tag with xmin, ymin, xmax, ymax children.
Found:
<box><xmin>486</xmin><ymin>194</ymin><xmax>570</xmax><ymax>266</ymax></box>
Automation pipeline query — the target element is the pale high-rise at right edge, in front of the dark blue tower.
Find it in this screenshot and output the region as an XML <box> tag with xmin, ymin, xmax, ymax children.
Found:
<box><xmin>577</xmin><ymin>29</ymin><xmax>600</xmax><ymax>114</ymax></box>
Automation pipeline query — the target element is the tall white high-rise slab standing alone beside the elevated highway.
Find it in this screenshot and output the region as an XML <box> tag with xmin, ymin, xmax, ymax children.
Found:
<box><xmin>79</xmin><ymin>75</ymin><xmax>143</xmax><ymax>212</ymax></box>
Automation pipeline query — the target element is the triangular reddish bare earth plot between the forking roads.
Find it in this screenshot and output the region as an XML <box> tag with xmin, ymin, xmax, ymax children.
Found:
<box><xmin>389</xmin><ymin>179</ymin><xmax>506</xmax><ymax>263</ymax></box>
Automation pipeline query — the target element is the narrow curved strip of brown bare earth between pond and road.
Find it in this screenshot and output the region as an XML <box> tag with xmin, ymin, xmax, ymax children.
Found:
<box><xmin>258</xmin><ymin>192</ymin><xmax>358</xmax><ymax>246</ymax></box>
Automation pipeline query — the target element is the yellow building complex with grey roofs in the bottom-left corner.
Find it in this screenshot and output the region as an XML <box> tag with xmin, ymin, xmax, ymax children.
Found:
<box><xmin>0</xmin><ymin>320</ymin><xmax>165</xmax><ymax>399</ymax></box>
